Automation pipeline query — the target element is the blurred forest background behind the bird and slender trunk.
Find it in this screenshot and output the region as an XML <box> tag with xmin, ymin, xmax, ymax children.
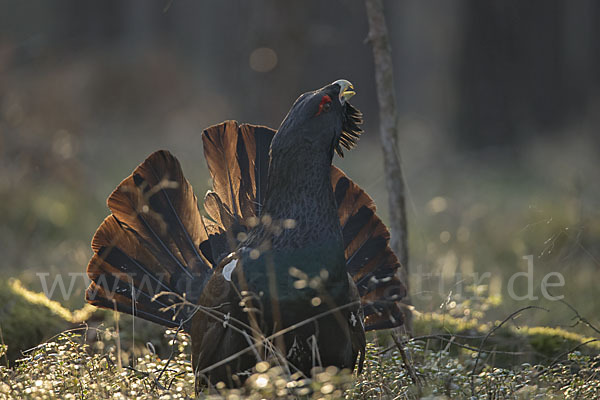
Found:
<box><xmin>0</xmin><ymin>0</ymin><xmax>600</xmax><ymax>332</ymax></box>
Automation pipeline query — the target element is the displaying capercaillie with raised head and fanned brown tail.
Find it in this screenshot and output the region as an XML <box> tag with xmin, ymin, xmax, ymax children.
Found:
<box><xmin>86</xmin><ymin>80</ymin><xmax>406</xmax><ymax>389</ymax></box>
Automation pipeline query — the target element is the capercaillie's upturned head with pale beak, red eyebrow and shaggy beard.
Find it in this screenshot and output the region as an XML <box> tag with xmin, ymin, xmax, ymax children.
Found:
<box><xmin>271</xmin><ymin>79</ymin><xmax>362</xmax><ymax>158</ymax></box>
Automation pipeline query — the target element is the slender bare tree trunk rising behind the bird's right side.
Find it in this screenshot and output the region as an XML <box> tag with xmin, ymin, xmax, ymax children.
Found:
<box><xmin>365</xmin><ymin>0</ymin><xmax>412</xmax><ymax>334</ymax></box>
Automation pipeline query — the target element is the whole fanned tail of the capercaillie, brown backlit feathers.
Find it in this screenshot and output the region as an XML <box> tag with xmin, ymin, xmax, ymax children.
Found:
<box><xmin>86</xmin><ymin>121</ymin><xmax>406</xmax><ymax>330</ymax></box>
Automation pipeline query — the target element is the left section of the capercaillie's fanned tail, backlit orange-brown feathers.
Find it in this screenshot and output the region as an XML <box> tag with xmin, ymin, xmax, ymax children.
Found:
<box><xmin>86</xmin><ymin>151</ymin><xmax>213</xmax><ymax>327</ymax></box>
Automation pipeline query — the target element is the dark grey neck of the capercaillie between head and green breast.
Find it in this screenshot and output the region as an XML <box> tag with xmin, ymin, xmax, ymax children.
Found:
<box><xmin>261</xmin><ymin>147</ymin><xmax>342</xmax><ymax>248</ymax></box>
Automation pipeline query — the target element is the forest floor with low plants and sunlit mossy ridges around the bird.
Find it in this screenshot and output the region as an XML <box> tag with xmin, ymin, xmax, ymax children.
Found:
<box><xmin>0</xmin><ymin>281</ymin><xmax>600</xmax><ymax>399</ymax></box>
